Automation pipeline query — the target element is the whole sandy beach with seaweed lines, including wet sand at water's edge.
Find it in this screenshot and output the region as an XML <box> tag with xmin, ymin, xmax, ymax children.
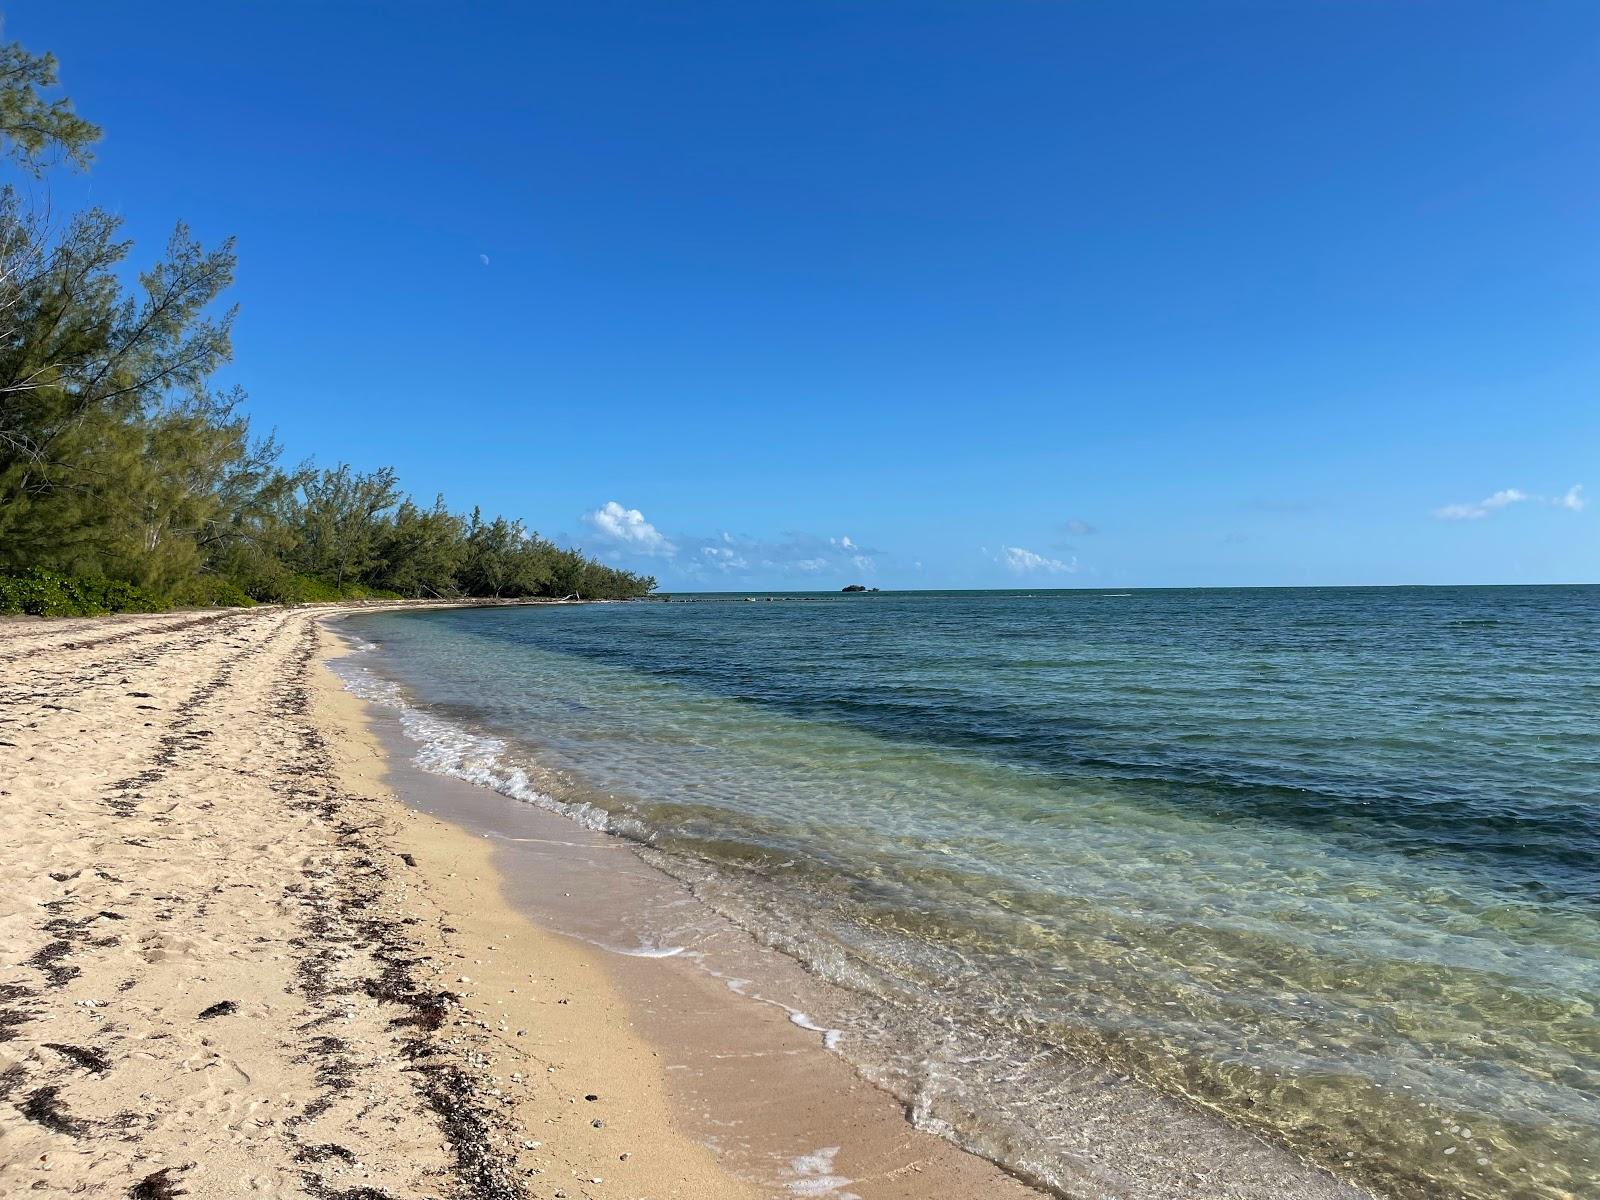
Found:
<box><xmin>0</xmin><ymin>608</ymin><xmax>1034</xmax><ymax>1200</ymax></box>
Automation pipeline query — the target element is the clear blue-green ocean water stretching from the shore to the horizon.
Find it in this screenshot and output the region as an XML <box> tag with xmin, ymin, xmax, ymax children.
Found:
<box><xmin>347</xmin><ymin>587</ymin><xmax>1600</xmax><ymax>1200</ymax></box>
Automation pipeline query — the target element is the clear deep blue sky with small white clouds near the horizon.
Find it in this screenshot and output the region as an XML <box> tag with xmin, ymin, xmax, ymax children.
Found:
<box><xmin>15</xmin><ymin>0</ymin><xmax>1600</xmax><ymax>589</ymax></box>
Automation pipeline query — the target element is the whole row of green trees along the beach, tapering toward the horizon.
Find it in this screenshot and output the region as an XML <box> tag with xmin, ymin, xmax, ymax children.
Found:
<box><xmin>0</xmin><ymin>43</ymin><xmax>654</xmax><ymax>614</ymax></box>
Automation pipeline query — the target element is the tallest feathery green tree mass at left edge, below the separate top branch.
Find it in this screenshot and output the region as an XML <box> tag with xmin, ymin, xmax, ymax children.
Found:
<box><xmin>0</xmin><ymin>208</ymin><xmax>248</xmax><ymax>590</ymax></box>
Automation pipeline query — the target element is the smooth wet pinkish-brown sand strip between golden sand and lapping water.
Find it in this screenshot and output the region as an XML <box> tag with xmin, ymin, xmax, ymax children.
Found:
<box><xmin>320</xmin><ymin>621</ymin><xmax>1046</xmax><ymax>1200</ymax></box>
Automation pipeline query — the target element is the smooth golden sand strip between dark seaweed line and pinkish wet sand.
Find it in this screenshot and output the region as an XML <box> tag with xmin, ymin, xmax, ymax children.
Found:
<box><xmin>310</xmin><ymin>620</ymin><xmax>758</xmax><ymax>1200</ymax></box>
